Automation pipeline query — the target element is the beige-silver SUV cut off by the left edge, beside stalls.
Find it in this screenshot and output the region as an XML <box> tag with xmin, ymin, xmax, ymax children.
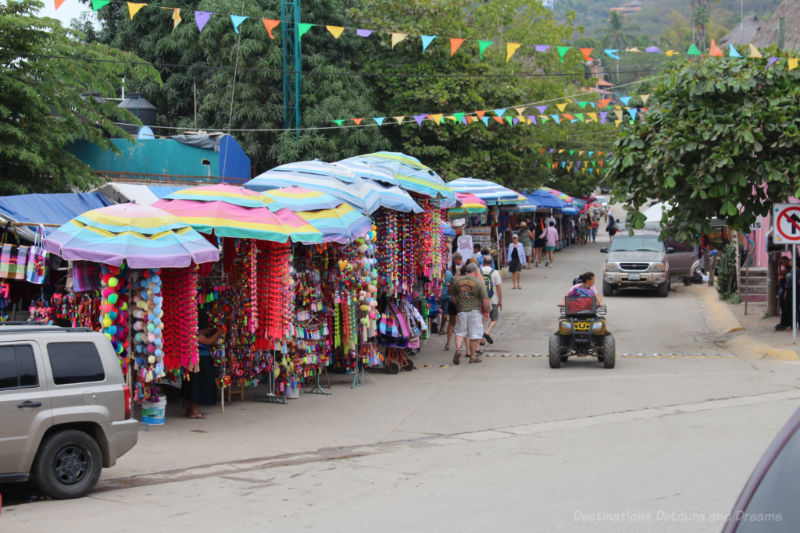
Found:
<box><xmin>0</xmin><ymin>324</ymin><xmax>138</xmax><ymax>498</ymax></box>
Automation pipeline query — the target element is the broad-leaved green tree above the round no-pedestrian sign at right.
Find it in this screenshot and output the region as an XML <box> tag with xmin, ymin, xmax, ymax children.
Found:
<box><xmin>609</xmin><ymin>48</ymin><xmax>800</xmax><ymax>238</ymax></box>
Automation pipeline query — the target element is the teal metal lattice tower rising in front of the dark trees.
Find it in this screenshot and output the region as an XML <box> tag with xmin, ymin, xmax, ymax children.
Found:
<box><xmin>281</xmin><ymin>0</ymin><xmax>303</xmax><ymax>138</ymax></box>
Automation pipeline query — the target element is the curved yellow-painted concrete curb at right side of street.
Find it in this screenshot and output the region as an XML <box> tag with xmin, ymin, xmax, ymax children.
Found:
<box><xmin>702</xmin><ymin>287</ymin><xmax>800</xmax><ymax>361</ymax></box>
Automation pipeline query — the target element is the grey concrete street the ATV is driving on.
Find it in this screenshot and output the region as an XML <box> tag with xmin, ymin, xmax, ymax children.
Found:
<box><xmin>0</xmin><ymin>237</ymin><xmax>800</xmax><ymax>533</ymax></box>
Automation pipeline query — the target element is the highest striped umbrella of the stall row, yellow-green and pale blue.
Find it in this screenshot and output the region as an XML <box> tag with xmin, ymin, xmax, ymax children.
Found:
<box><xmin>344</xmin><ymin>152</ymin><xmax>453</xmax><ymax>198</ymax></box>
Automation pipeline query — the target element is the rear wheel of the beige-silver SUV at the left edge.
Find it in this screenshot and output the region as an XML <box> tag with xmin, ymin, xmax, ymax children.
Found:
<box><xmin>32</xmin><ymin>429</ymin><xmax>103</xmax><ymax>499</ymax></box>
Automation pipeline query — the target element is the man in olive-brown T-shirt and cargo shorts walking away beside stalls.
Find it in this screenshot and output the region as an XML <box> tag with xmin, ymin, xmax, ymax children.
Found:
<box><xmin>450</xmin><ymin>263</ymin><xmax>491</xmax><ymax>365</ymax></box>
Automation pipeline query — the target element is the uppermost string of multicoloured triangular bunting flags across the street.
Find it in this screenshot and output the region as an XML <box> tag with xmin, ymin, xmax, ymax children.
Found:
<box><xmin>62</xmin><ymin>0</ymin><xmax>800</xmax><ymax>70</ymax></box>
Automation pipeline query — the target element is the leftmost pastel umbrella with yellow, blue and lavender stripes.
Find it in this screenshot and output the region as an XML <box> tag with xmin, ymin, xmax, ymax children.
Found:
<box><xmin>43</xmin><ymin>204</ymin><xmax>219</xmax><ymax>268</ymax></box>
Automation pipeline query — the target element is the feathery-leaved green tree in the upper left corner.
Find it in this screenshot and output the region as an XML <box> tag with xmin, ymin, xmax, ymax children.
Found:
<box><xmin>0</xmin><ymin>0</ymin><xmax>158</xmax><ymax>194</ymax></box>
